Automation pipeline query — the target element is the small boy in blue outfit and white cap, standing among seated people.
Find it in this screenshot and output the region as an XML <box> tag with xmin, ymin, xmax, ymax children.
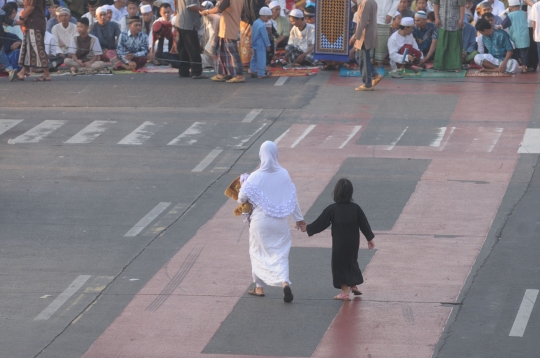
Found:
<box><xmin>249</xmin><ymin>6</ymin><xmax>272</xmax><ymax>78</ymax></box>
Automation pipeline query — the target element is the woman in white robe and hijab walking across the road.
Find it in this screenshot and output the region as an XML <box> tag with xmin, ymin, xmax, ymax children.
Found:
<box><xmin>238</xmin><ymin>141</ymin><xmax>305</xmax><ymax>302</ymax></box>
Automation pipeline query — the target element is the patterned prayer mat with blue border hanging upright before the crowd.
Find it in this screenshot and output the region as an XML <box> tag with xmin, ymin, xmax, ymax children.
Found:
<box><xmin>313</xmin><ymin>0</ymin><xmax>352</xmax><ymax>62</ymax></box>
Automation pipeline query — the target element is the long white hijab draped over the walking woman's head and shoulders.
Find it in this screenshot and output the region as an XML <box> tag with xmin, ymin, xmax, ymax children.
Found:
<box><xmin>241</xmin><ymin>141</ymin><xmax>296</xmax><ymax>218</ymax></box>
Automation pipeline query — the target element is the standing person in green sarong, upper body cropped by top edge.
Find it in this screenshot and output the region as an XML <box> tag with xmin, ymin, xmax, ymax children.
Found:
<box><xmin>432</xmin><ymin>0</ymin><xmax>465</xmax><ymax>71</ymax></box>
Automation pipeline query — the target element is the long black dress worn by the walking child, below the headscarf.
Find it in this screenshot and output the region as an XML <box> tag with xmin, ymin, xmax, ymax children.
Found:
<box><xmin>307</xmin><ymin>201</ymin><xmax>375</xmax><ymax>288</ymax></box>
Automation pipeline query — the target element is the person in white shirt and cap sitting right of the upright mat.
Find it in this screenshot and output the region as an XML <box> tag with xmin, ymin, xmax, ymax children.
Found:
<box><xmin>388</xmin><ymin>17</ymin><xmax>424</xmax><ymax>71</ymax></box>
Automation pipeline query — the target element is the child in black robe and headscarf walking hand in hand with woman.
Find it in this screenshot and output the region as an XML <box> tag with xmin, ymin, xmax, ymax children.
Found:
<box><xmin>300</xmin><ymin>178</ymin><xmax>375</xmax><ymax>301</ymax></box>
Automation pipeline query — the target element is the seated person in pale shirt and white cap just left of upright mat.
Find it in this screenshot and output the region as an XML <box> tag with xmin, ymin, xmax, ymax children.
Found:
<box><xmin>285</xmin><ymin>9</ymin><xmax>318</xmax><ymax>66</ymax></box>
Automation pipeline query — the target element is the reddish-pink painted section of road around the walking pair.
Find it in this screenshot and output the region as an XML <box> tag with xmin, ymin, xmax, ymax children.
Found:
<box><xmin>84</xmin><ymin>76</ymin><xmax>536</xmax><ymax>358</ymax></box>
